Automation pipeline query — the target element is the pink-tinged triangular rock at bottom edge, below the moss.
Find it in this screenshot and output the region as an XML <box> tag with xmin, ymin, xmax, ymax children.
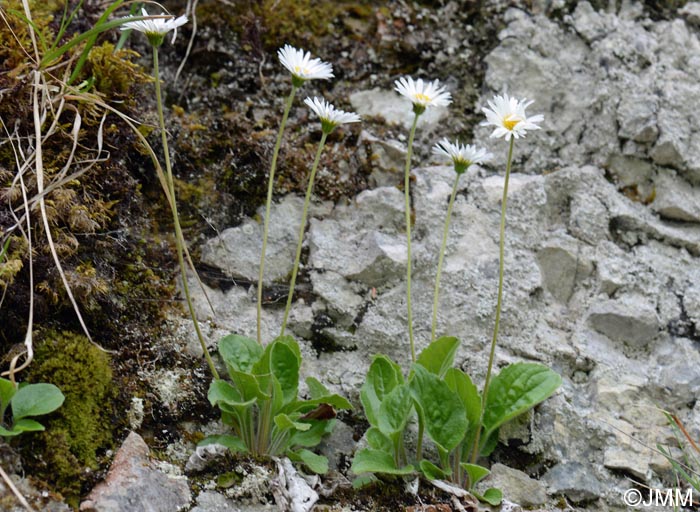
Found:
<box><xmin>80</xmin><ymin>432</ymin><xmax>191</xmax><ymax>512</ymax></box>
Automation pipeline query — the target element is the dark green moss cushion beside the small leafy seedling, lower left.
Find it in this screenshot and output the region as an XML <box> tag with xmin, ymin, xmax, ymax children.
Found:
<box><xmin>22</xmin><ymin>331</ymin><xmax>115</xmax><ymax>504</ymax></box>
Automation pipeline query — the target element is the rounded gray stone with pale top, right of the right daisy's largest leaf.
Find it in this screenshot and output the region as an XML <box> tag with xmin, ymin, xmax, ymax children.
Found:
<box><xmin>588</xmin><ymin>295</ymin><xmax>660</xmax><ymax>345</ymax></box>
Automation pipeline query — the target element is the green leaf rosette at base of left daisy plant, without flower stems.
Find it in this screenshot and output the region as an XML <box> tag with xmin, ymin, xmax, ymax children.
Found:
<box><xmin>200</xmin><ymin>334</ymin><xmax>351</xmax><ymax>473</ymax></box>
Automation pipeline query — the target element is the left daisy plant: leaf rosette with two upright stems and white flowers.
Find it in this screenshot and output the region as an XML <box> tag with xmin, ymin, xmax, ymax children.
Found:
<box><xmin>202</xmin><ymin>45</ymin><xmax>360</xmax><ymax>473</ymax></box>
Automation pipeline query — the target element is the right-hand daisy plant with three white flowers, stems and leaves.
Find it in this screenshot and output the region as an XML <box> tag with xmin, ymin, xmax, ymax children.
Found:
<box><xmin>352</xmin><ymin>87</ymin><xmax>561</xmax><ymax>505</ymax></box>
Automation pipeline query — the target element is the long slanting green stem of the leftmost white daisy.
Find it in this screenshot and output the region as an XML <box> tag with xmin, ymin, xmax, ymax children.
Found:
<box><xmin>153</xmin><ymin>46</ymin><xmax>219</xmax><ymax>379</ymax></box>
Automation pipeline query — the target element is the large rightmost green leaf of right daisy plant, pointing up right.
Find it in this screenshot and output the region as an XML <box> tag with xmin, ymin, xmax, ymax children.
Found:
<box><xmin>484</xmin><ymin>363</ymin><xmax>561</xmax><ymax>438</ymax></box>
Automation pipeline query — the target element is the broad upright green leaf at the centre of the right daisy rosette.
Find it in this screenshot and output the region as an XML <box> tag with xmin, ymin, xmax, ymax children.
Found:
<box><xmin>410</xmin><ymin>364</ymin><xmax>469</xmax><ymax>452</ymax></box>
